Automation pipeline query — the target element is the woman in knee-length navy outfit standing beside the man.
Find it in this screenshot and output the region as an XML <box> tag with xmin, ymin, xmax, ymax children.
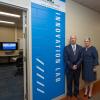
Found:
<box><xmin>82</xmin><ymin>38</ymin><xmax>98</xmax><ymax>98</ymax></box>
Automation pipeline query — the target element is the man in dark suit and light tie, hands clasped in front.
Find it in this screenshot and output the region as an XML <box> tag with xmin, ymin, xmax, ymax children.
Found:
<box><xmin>64</xmin><ymin>35</ymin><xmax>82</xmax><ymax>100</ymax></box>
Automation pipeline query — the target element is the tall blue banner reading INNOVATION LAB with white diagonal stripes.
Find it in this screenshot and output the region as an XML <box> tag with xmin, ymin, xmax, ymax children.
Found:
<box><xmin>31</xmin><ymin>3</ymin><xmax>65</xmax><ymax>100</ymax></box>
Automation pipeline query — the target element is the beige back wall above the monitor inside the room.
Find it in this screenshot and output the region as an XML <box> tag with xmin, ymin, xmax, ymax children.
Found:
<box><xmin>0</xmin><ymin>25</ymin><xmax>23</xmax><ymax>42</ymax></box>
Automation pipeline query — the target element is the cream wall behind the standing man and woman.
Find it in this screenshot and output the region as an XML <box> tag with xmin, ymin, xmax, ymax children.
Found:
<box><xmin>66</xmin><ymin>0</ymin><xmax>100</xmax><ymax>87</ymax></box>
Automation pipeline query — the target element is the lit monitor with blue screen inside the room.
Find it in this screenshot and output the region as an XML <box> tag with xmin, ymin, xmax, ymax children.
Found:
<box><xmin>2</xmin><ymin>42</ymin><xmax>18</xmax><ymax>50</ymax></box>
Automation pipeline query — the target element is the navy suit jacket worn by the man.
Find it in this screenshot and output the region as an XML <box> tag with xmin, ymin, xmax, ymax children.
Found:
<box><xmin>64</xmin><ymin>44</ymin><xmax>82</xmax><ymax>70</ymax></box>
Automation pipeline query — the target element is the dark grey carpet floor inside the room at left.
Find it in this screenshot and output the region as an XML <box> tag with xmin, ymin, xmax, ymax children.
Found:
<box><xmin>0</xmin><ymin>64</ymin><xmax>24</xmax><ymax>100</ymax></box>
